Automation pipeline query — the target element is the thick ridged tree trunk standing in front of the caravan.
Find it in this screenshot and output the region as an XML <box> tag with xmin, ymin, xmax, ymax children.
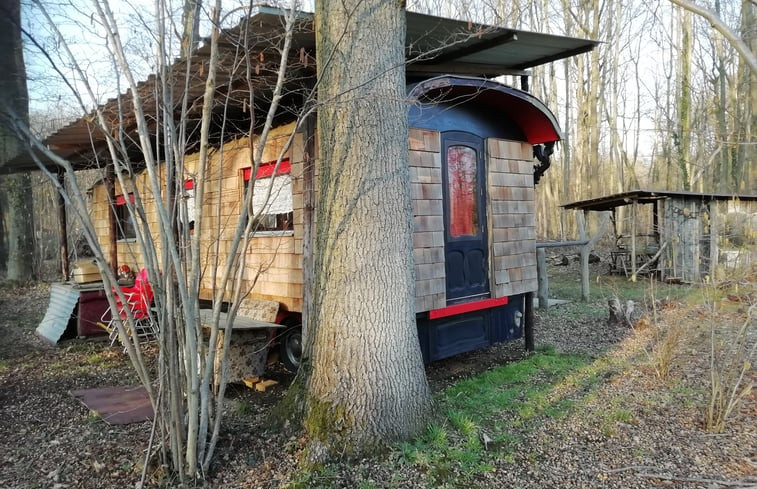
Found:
<box><xmin>301</xmin><ymin>0</ymin><xmax>430</xmax><ymax>460</ymax></box>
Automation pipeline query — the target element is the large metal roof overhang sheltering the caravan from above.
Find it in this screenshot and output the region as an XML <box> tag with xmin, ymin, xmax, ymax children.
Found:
<box><xmin>0</xmin><ymin>7</ymin><xmax>598</xmax><ymax>173</ymax></box>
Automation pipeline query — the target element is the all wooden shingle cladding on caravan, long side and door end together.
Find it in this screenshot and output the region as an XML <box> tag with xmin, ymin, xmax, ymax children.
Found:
<box><xmin>92</xmin><ymin>125</ymin><xmax>536</xmax><ymax>312</ymax></box>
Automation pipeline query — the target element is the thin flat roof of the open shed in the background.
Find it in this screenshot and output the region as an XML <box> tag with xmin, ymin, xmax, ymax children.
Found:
<box><xmin>562</xmin><ymin>189</ymin><xmax>757</xmax><ymax>211</ymax></box>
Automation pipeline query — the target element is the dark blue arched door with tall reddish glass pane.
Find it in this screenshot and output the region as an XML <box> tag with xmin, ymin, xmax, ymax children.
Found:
<box><xmin>442</xmin><ymin>132</ymin><xmax>489</xmax><ymax>304</ymax></box>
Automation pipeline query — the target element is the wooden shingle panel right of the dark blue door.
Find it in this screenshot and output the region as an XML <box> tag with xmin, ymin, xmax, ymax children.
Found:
<box><xmin>487</xmin><ymin>139</ymin><xmax>537</xmax><ymax>297</ymax></box>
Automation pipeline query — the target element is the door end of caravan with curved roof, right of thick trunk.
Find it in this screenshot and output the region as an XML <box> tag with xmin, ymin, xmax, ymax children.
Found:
<box><xmin>409</xmin><ymin>76</ymin><xmax>560</xmax><ymax>361</ymax></box>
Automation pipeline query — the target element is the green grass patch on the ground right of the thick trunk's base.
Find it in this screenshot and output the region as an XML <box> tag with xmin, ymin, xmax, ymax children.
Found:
<box><xmin>398</xmin><ymin>349</ymin><xmax>616</xmax><ymax>487</ymax></box>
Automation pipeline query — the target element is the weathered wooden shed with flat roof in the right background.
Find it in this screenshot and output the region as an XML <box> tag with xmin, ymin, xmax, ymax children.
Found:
<box><xmin>563</xmin><ymin>189</ymin><xmax>757</xmax><ymax>282</ymax></box>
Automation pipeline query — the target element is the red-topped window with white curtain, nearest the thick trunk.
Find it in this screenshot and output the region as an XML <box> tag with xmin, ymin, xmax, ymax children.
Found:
<box><xmin>243</xmin><ymin>159</ymin><xmax>294</xmax><ymax>232</ymax></box>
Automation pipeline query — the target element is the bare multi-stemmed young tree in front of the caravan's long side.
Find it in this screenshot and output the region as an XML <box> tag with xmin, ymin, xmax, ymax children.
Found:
<box><xmin>3</xmin><ymin>0</ymin><xmax>306</xmax><ymax>481</ymax></box>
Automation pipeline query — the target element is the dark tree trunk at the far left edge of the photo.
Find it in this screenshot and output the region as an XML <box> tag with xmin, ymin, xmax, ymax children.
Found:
<box><xmin>0</xmin><ymin>0</ymin><xmax>34</xmax><ymax>280</ymax></box>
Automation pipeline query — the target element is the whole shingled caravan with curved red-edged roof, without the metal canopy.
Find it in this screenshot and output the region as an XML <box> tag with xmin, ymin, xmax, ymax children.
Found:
<box><xmin>87</xmin><ymin>76</ymin><xmax>560</xmax><ymax>361</ymax></box>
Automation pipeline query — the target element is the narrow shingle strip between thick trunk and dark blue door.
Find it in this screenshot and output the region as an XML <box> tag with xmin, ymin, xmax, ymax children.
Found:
<box><xmin>410</xmin><ymin>128</ymin><xmax>447</xmax><ymax>312</ymax></box>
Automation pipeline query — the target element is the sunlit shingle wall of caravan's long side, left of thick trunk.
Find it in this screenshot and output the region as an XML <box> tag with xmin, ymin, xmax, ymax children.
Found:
<box><xmin>91</xmin><ymin>124</ymin><xmax>302</xmax><ymax>311</ymax></box>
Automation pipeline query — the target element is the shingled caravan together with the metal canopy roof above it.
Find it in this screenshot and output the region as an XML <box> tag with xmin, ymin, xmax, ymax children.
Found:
<box><xmin>2</xmin><ymin>7</ymin><xmax>596</xmax><ymax>363</ymax></box>
